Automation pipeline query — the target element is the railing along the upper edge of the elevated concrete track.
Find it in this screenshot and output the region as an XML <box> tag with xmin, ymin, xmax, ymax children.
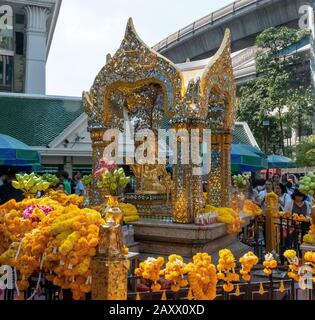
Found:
<box><xmin>153</xmin><ymin>0</ymin><xmax>266</xmax><ymax>51</ymax></box>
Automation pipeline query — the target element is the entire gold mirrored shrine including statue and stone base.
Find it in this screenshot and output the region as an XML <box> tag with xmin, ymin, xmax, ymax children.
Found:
<box><xmin>83</xmin><ymin>18</ymin><xmax>247</xmax><ymax>266</ymax></box>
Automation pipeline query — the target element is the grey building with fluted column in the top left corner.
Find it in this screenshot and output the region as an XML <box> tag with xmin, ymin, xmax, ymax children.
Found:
<box><xmin>0</xmin><ymin>0</ymin><xmax>61</xmax><ymax>94</ymax></box>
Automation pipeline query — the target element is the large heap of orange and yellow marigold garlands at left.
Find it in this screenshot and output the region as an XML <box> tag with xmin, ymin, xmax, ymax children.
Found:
<box><xmin>0</xmin><ymin>191</ymin><xmax>104</xmax><ymax>299</ymax></box>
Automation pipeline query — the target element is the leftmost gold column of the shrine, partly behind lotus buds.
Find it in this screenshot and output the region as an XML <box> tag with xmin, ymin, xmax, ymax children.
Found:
<box><xmin>90</xmin><ymin>129</ymin><xmax>106</xmax><ymax>206</ymax></box>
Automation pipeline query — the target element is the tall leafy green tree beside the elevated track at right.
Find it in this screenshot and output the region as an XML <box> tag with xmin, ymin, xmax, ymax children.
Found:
<box><xmin>238</xmin><ymin>27</ymin><xmax>314</xmax><ymax>154</ymax></box>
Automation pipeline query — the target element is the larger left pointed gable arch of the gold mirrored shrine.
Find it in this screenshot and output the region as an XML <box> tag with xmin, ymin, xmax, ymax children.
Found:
<box><xmin>83</xmin><ymin>18</ymin><xmax>183</xmax><ymax>130</ymax></box>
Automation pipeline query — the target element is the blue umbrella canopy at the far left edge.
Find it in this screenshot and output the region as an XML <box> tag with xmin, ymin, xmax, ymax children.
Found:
<box><xmin>0</xmin><ymin>134</ymin><xmax>40</xmax><ymax>167</ymax></box>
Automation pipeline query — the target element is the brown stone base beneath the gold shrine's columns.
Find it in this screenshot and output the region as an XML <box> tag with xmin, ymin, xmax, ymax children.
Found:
<box><xmin>133</xmin><ymin>214</ymin><xmax>251</xmax><ymax>262</ymax></box>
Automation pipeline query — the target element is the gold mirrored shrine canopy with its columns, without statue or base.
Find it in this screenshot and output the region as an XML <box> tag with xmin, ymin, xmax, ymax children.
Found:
<box><xmin>83</xmin><ymin>18</ymin><xmax>237</xmax><ymax>223</ymax></box>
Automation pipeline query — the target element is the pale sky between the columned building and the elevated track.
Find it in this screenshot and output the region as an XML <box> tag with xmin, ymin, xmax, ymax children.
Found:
<box><xmin>47</xmin><ymin>0</ymin><xmax>232</xmax><ymax>96</ymax></box>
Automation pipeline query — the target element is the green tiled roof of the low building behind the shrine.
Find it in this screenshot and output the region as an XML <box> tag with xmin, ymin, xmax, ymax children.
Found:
<box><xmin>0</xmin><ymin>94</ymin><xmax>257</xmax><ymax>147</ymax></box>
